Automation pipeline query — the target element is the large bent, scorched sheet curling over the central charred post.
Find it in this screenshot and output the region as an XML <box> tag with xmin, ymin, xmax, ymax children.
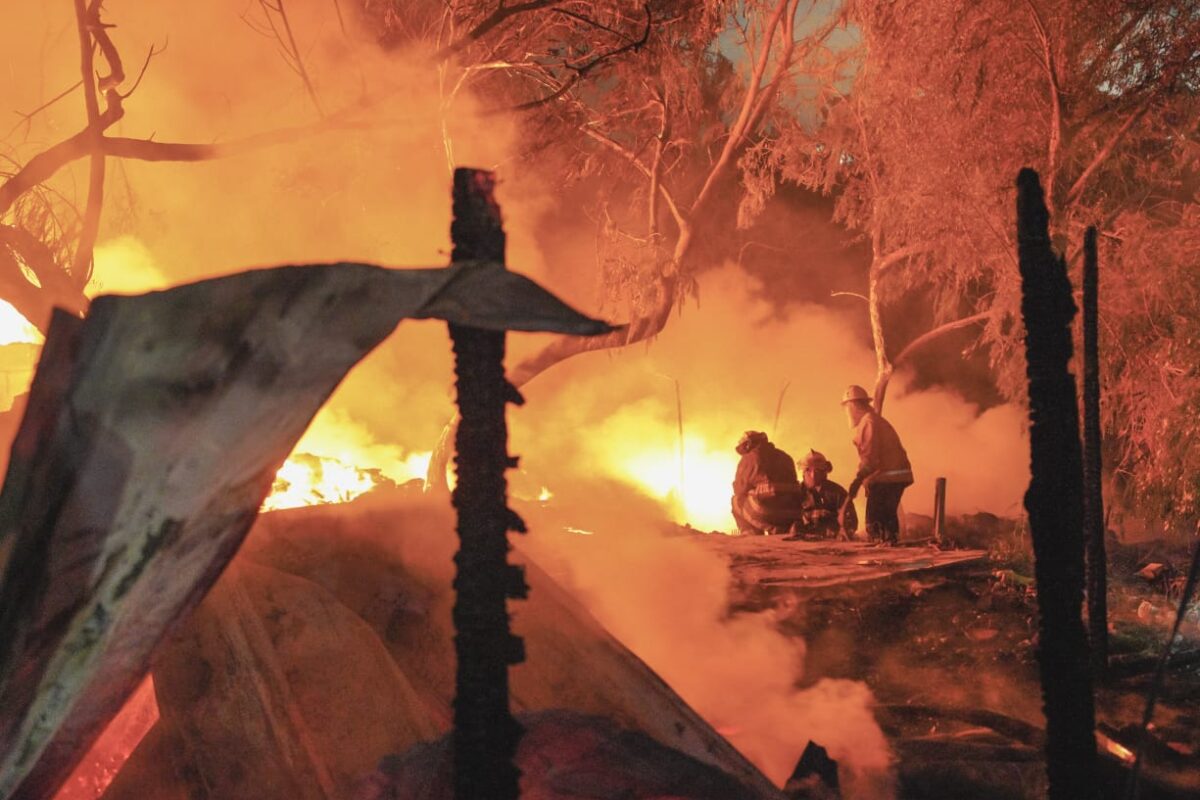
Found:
<box><xmin>0</xmin><ymin>264</ymin><xmax>610</xmax><ymax>800</ymax></box>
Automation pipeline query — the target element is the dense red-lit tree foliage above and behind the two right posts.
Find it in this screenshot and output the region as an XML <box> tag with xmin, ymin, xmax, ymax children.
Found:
<box><xmin>780</xmin><ymin>0</ymin><xmax>1200</xmax><ymax>532</ymax></box>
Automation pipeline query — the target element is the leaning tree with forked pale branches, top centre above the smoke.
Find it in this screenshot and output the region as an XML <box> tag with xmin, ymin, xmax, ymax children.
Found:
<box><xmin>417</xmin><ymin>0</ymin><xmax>853</xmax><ymax>485</ymax></box>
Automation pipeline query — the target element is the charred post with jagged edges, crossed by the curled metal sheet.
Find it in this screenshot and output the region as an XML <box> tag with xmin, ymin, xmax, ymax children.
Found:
<box><xmin>450</xmin><ymin>169</ymin><xmax>527</xmax><ymax>800</ymax></box>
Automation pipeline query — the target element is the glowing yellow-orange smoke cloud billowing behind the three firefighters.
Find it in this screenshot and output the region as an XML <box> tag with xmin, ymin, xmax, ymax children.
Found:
<box><xmin>512</xmin><ymin>266</ymin><xmax>1028</xmax><ymax>530</ymax></box>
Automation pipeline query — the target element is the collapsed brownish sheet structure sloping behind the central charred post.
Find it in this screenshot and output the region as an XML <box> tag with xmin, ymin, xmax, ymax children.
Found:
<box><xmin>93</xmin><ymin>492</ymin><xmax>781</xmax><ymax>800</ymax></box>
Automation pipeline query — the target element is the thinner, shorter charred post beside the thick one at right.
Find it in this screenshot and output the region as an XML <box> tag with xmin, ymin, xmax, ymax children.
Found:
<box><xmin>1084</xmin><ymin>228</ymin><xmax>1109</xmax><ymax>678</ymax></box>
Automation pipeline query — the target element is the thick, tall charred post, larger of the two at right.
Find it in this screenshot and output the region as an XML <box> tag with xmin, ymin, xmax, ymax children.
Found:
<box><xmin>1016</xmin><ymin>169</ymin><xmax>1098</xmax><ymax>800</ymax></box>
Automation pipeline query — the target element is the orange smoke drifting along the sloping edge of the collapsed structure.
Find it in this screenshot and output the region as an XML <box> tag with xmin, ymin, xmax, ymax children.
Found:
<box><xmin>514</xmin><ymin>482</ymin><xmax>892</xmax><ymax>799</ymax></box>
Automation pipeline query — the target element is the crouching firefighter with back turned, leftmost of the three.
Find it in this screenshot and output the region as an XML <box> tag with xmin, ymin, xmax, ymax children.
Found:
<box><xmin>732</xmin><ymin>431</ymin><xmax>803</xmax><ymax>535</ymax></box>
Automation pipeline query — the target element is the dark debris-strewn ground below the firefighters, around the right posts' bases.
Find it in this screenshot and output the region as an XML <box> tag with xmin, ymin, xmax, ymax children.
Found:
<box><xmin>715</xmin><ymin>518</ymin><xmax>1200</xmax><ymax>799</ymax></box>
